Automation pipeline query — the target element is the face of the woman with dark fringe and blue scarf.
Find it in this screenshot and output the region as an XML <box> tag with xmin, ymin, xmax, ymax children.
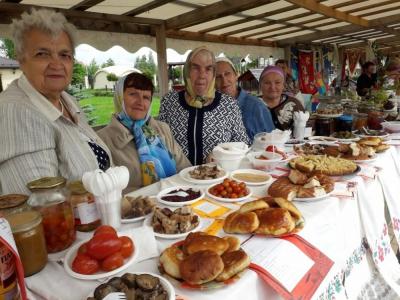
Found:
<box><xmin>124</xmin><ymin>87</ymin><xmax>151</xmax><ymax>120</ymax></box>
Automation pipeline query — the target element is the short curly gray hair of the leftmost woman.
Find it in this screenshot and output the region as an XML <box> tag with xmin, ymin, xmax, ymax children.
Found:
<box><xmin>11</xmin><ymin>9</ymin><xmax>76</xmax><ymax>58</ymax></box>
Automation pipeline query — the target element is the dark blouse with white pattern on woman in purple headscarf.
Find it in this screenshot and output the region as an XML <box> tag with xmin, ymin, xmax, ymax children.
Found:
<box><xmin>269</xmin><ymin>94</ymin><xmax>304</xmax><ymax>130</ymax></box>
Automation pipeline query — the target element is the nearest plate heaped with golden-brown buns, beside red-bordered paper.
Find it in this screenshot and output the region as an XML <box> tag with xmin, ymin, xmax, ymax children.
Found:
<box><xmin>159</xmin><ymin>232</ymin><xmax>250</xmax><ymax>290</ymax></box>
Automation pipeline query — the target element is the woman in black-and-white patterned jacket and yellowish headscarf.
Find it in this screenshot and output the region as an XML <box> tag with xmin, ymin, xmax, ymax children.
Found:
<box><xmin>159</xmin><ymin>47</ymin><xmax>249</xmax><ymax>165</ymax></box>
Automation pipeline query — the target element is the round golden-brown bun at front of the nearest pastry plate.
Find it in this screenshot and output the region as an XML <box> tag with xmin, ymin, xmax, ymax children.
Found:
<box><xmin>179</xmin><ymin>250</ymin><xmax>224</xmax><ymax>284</ymax></box>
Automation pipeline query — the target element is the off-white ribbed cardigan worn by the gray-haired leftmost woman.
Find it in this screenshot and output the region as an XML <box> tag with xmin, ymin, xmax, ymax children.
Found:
<box><xmin>0</xmin><ymin>75</ymin><xmax>111</xmax><ymax>194</ymax></box>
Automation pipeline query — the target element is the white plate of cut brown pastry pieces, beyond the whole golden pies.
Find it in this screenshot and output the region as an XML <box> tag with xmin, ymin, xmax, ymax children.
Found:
<box><xmin>268</xmin><ymin>169</ymin><xmax>335</xmax><ymax>201</ymax></box>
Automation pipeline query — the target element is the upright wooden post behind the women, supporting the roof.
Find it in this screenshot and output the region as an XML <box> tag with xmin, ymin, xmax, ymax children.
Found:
<box><xmin>156</xmin><ymin>24</ymin><xmax>168</xmax><ymax>98</ymax></box>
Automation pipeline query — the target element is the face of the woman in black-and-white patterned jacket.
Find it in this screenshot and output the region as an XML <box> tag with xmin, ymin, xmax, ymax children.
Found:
<box><xmin>189</xmin><ymin>52</ymin><xmax>214</xmax><ymax>96</ymax></box>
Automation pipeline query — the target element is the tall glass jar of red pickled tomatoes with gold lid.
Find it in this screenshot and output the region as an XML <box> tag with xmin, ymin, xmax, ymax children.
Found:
<box><xmin>28</xmin><ymin>177</ymin><xmax>75</xmax><ymax>253</ymax></box>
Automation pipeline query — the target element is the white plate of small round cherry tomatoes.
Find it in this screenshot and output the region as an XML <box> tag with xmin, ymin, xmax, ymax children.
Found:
<box><xmin>207</xmin><ymin>178</ymin><xmax>251</xmax><ymax>202</ymax></box>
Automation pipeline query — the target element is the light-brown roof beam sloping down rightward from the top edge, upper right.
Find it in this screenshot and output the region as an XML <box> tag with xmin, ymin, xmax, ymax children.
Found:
<box><xmin>287</xmin><ymin>0</ymin><xmax>369</xmax><ymax>27</ymax></box>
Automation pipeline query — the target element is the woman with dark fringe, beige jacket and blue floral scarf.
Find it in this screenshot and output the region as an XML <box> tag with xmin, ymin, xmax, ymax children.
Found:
<box><xmin>98</xmin><ymin>73</ymin><xmax>190</xmax><ymax>192</ymax></box>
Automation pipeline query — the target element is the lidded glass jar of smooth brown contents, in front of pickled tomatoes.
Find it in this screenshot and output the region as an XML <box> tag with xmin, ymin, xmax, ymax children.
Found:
<box><xmin>6</xmin><ymin>210</ymin><xmax>47</xmax><ymax>277</ymax></box>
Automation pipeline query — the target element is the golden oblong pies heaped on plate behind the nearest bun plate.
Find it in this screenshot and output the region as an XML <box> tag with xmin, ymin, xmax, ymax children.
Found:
<box><xmin>223</xmin><ymin>197</ymin><xmax>305</xmax><ymax>237</ymax></box>
